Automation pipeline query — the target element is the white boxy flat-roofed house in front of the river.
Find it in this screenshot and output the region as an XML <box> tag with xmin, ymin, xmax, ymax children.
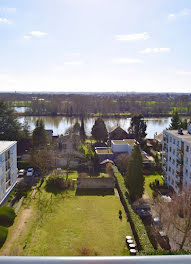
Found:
<box><xmin>111</xmin><ymin>139</ymin><xmax>135</xmax><ymax>154</ymax></box>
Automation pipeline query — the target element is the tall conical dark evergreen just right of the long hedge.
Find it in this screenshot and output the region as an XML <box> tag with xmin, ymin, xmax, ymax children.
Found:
<box><xmin>125</xmin><ymin>144</ymin><xmax>144</xmax><ymax>200</ymax></box>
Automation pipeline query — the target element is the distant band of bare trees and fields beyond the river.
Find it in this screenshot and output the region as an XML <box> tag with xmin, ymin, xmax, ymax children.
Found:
<box><xmin>0</xmin><ymin>93</ymin><xmax>191</xmax><ymax>117</ymax></box>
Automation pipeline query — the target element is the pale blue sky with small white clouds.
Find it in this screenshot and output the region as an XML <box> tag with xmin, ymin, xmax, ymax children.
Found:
<box><xmin>0</xmin><ymin>0</ymin><xmax>191</xmax><ymax>93</ymax></box>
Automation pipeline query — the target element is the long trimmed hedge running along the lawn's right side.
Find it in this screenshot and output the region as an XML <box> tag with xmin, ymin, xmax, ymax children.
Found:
<box><xmin>113</xmin><ymin>166</ymin><xmax>154</xmax><ymax>251</ymax></box>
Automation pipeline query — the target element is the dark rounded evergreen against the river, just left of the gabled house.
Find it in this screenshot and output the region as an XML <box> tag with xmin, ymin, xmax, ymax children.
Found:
<box><xmin>92</xmin><ymin>117</ymin><xmax>108</xmax><ymax>142</ymax></box>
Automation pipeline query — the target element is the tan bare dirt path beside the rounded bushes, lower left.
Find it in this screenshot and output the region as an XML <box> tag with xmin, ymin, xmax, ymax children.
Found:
<box><xmin>1</xmin><ymin>207</ymin><xmax>32</xmax><ymax>256</ymax></box>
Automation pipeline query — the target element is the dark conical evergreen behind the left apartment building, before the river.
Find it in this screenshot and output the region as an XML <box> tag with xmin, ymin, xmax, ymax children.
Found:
<box><xmin>32</xmin><ymin>119</ymin><xmax>48</xmax><ymax>148</ymax></box>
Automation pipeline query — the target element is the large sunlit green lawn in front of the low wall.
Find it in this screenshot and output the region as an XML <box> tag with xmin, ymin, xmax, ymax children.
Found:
<box><xmin>7</xmin><ymin>182</ymin><xmax>131</xmax><ymax>256</ymax></box>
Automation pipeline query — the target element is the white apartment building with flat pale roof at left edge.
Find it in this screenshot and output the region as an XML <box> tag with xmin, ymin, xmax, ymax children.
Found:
<box><xmin>0</xmin><ymin>141</ymin><xmax>17</xmax><ymax>204</ymax></box>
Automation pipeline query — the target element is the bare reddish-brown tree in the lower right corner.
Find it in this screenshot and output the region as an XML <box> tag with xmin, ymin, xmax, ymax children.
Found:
<box><xmin>156</xmin><ymin>188</ymin><xmax>191</xmax><ymax>249</ymax></box>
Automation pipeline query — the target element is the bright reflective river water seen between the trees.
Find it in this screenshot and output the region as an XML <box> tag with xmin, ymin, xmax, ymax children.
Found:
<box><xmin>18</xmin><ymin>116</ymin><xmax>171</xmax><ymax>138</ymax></box>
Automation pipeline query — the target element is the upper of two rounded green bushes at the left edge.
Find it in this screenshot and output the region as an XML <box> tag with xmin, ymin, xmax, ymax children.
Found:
<box><xmin>0</xmin><ymin>206</ymin><xmax>16</xmax><ymax>227</ymax></box>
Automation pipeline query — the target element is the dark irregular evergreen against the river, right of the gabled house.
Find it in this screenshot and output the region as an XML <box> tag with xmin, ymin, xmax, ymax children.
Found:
<box><xmin>128</xmin><ymin>114</ymin><xmax>147</xmax><ymax>143</ymax></box>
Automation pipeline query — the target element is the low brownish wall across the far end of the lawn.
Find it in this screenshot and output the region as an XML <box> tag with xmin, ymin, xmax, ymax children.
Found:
<box><xmin>77</xmin><ymin>177</ymin><xmax>115</xmax><ymax>189</ymax></box>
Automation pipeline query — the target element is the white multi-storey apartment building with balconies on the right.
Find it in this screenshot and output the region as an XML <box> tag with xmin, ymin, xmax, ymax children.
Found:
<box><xmin>162</xmin><ymin>124</ymin><xmax>191</xmax><ymax>193</ymax></box>
